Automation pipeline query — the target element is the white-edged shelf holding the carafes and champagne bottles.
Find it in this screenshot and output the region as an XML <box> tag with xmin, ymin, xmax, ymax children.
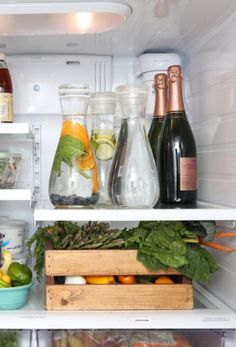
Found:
<box><xmin>34</xmin><ymin>203</ymin><xmax>236</xmax><ymax>221</ymax></box>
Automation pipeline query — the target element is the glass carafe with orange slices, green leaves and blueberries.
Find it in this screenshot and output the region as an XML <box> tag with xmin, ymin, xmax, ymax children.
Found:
<box><xmin>49</xmin><ymin>84</ymin><xmax>99</xmax><ymax>208</ymax></box>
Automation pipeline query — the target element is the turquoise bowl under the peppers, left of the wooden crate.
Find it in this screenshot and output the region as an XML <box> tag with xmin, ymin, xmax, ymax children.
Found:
<box><xmin>0</xmin><ymin>282</ymin><xmax>33</xmax><ymax>310</ymax></box>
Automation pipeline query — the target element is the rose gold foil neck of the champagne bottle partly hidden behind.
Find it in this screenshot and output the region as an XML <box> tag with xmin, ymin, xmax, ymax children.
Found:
<box><xmin>154</xmin><ymin>73</ymin><xmax>168</xmax><ymax>118</ymax></box>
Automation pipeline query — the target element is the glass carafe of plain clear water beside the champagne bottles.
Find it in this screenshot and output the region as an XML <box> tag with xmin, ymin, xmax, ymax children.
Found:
<box><xmin>109</xmin><ymin>85</ymin><xmax>159</xmax><ymax>208</ymax></box>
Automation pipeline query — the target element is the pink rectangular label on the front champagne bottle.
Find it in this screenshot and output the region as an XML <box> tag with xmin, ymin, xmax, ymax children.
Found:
<box><xmin>180</xmin><ymin>157</ymin><xmax>197</xmax><ymax>191</ymax></box>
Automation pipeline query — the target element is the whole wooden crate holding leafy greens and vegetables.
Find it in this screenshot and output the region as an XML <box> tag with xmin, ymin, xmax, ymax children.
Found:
<box><xmin>45</xmin><ymin>249</ymin><xmax>193</xmax><ymax>310</ymax></box>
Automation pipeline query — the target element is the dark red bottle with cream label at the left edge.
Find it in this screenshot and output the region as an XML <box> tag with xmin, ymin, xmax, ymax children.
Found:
<box><xmin>0</xmin><ymin>53</ymin><xmax>13</xmax><ymax>123</ymax></box>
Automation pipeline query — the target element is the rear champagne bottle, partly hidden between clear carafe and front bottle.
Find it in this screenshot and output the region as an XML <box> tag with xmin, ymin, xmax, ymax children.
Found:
<box><xmin>148</xmin><ymin>73</ymin><xmax>167</xmax><ymax>164</ymax></box>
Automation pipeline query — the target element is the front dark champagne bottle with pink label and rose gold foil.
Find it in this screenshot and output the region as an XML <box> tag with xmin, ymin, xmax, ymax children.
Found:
<box><xmin>158</xmin><ymin>65</ymin><xmax>197</xmax><ymax>204</ymax></box>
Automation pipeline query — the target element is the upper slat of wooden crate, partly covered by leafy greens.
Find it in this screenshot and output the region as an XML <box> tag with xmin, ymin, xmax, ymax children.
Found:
<box><xmin>45</xmin><ymin>250</ymin><xmax>179</xmax><ymax>276</ymax></box>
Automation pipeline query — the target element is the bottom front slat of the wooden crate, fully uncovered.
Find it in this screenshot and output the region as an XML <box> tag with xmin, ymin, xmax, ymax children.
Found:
<box><xmin>46</xmin><ymin>284</ymin><xmax>193</xmax><ymax>310</ymax></box>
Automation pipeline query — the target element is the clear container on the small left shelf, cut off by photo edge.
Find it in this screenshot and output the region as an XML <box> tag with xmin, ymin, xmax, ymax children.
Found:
<box><xmin>0</xmin><ymin>152</ymin><xmax>21</xmax><ymax>189</ymax></box>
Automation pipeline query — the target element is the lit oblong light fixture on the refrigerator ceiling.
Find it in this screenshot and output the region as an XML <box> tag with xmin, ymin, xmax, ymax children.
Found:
<box><xmin>0</xmin><ymin>1</ymin><xmax>132</xmax><ymax>35</ymax></box>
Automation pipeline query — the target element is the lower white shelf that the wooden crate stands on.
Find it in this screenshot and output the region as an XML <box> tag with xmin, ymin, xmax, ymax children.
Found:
<box><xmin>0</xmin><ymin>285</ymin><xmax>236</xmax><ymax>330</ymax></box>
